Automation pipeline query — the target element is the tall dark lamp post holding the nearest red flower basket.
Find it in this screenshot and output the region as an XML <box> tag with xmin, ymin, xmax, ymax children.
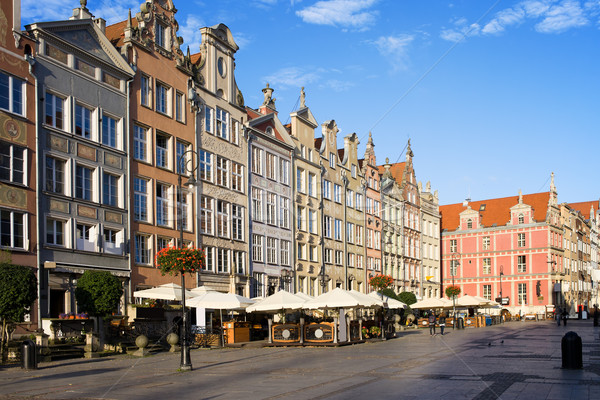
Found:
<box><xmin>177</xmin><ymin>149</ymin><xmax>198</xmax><ymax>371</ymax></box>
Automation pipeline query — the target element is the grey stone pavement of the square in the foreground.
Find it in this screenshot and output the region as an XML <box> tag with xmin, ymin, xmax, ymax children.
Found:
<box><xmin>0</xmin><ymin>320</ymin><xmax>600</xmax><ymax>400</ymax></box>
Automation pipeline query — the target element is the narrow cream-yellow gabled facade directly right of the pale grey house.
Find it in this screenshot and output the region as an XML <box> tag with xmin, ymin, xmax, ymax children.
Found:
<box><xmin>289</xmin><ymin>88</ymin><xmax>329</xmax><ymax>296</ymax></box>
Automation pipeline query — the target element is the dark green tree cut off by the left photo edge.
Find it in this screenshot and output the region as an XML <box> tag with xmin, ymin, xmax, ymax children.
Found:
<box><xmin>0</xmin><ymin>262</ymin><xmax>37</xmax><ymax>360</ymax></box>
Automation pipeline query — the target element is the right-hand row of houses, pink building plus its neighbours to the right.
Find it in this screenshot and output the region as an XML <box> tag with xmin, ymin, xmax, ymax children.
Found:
<box><xmin>440</xmin><ymin>174</ymin><xmax>600</xmax><ymax>315</ymax></box>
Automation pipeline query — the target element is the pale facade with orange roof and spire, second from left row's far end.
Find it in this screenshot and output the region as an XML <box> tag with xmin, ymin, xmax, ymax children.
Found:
<box><xmin>379</xmin><ymin>140</ymin><xmax>423</xmax><ymax>297</ymax></box>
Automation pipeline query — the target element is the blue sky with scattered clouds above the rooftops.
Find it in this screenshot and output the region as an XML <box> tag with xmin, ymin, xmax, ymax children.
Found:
<box><xmin>22</xmin><ymin>0</ymin><xmax>600</xmax><ymax>204</ymax></box>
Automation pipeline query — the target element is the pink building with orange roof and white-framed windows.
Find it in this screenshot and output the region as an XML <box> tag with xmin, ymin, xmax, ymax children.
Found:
<box><xmin>440</xmin><ymin>178</ymin><xmax>563</xmax><ymax>314</ymax></box>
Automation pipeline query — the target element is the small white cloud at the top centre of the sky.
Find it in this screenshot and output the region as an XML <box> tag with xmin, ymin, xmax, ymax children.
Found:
<box><xmin>296</xmin><ymin>0</ymin><xmax>378</xmax><ymax>29</ymax></box>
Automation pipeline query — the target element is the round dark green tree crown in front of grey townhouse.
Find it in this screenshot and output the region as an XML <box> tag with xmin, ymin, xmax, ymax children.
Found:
<box><xmin>75</xmin><ymin>271</ymin><xmax>123</xmax><ymax>317</ymax></box>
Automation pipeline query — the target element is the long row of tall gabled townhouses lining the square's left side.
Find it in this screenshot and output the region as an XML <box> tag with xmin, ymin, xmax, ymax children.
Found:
<box><xmin>0</xmin><ymin>0</ymin><xmax>441</xmax><ymax>332</ymax></box>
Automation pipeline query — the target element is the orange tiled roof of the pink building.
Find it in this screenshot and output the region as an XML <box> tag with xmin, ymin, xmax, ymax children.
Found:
<box><xmin>440</xmin><ymin>192</ymin><xmax>550</xmax><ymax>231</ymax></box>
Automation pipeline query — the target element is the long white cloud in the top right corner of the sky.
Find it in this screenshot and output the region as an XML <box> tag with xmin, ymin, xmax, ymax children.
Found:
<box><xmin>440</xmin><ymin>0</ymin><xmax>600</xmax><ymax>41</ymax></box>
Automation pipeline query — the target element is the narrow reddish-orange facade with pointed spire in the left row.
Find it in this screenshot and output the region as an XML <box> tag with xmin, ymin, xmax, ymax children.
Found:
<box><xmin>355</xmin><ymin>132</ymin><xmax>378</xmax><ymax>292</ymax></box>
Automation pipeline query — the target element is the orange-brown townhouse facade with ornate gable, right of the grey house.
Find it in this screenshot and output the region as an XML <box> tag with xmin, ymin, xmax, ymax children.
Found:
<box><xmin>107</xmin><ymin>0</ymin><xmax>199</xmax><ymax>291</ymax></box>
